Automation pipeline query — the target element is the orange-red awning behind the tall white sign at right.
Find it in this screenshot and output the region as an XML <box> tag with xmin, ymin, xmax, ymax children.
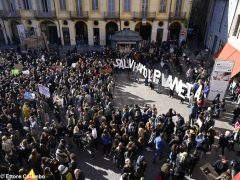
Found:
<box><xmin>213</xmin><ymin>43</ymin><xmax>240</xmax><ymax>78</ymax></box>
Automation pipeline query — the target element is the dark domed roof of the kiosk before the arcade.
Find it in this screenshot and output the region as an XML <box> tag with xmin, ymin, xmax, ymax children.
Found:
<box><xmin>112</xmin><ymin>29</ymin><xmax>142</xmax><ymax>42</ymax></box>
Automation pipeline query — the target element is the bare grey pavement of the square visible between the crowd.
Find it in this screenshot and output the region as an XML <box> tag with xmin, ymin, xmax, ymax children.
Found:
<box><xmin>74</xmin><ymin>73</ymin><xmax>239</xmax><ymax>180</ymax></box>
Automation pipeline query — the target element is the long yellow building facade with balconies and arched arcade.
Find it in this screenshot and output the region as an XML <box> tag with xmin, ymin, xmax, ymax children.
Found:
<box><xmin>0</xmin><ymin>0</ymin><xmax>192</xmax><ymax>45</ymax></box>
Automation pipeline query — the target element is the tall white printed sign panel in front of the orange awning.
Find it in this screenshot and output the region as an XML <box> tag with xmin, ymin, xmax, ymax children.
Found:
<box><xmin>208</xmin><ymin>60</ymin><xmax>234</xmax><ymax>101</ymax></box>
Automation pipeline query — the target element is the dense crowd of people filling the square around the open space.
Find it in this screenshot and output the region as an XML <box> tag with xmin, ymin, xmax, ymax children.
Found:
<box><xmin>0</xmin><ymin>43</ymin><xmax>240</xmax><ymax>180</ymax></box>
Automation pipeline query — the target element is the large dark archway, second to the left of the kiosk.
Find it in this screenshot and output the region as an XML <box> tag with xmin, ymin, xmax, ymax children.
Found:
<box><xmin>75</xmin><ymin>21</ymin><xmax>88</xmax><ymax>45</ymax></box>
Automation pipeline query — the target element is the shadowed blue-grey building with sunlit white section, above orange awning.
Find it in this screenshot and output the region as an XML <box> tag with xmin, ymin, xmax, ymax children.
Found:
<box><xmin>204</xmin><ymin>0</ymin><xmax>240</xmax><ymax>54</ymax></box>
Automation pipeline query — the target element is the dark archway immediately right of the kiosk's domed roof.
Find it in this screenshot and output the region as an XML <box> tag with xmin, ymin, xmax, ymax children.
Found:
<box><xmin>135</xmin><ymin>22</ymin><xmax>152</xmax><ymax>41</ymax></box>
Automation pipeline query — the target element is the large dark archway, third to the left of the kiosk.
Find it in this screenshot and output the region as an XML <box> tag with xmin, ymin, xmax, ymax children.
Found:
<box><xmin>40</xmin><ymin>21</ymin><xmax>58</xmax><ymax>44</ymax></box>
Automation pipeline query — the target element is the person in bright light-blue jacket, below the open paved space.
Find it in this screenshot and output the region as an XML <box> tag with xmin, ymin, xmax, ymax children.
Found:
<box><xmin>153</xmin><ymin>133</ymin><xmax>165</xmax><ymax>163</ymax></box>
